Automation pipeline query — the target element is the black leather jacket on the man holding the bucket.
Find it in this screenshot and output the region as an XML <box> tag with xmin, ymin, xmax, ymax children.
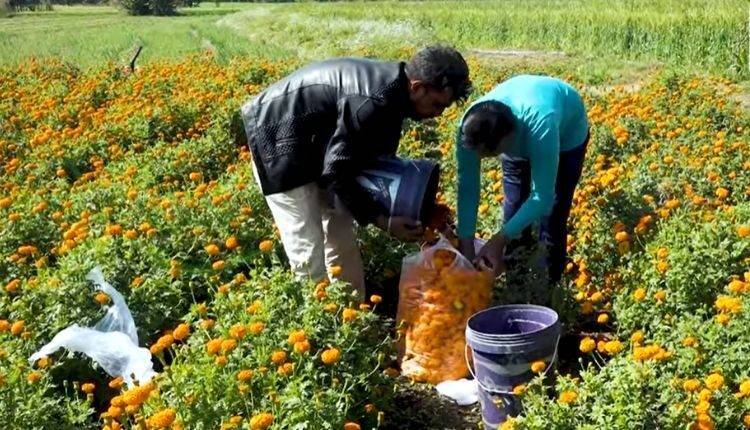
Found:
<box><xmin>241</xmin><ymin>58</ymin><xmax>411</xmax><ymax>225</ymax></box>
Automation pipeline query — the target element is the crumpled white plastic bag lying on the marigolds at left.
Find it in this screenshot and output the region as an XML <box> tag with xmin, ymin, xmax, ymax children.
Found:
<box><xmin>29</xmin><ymin>267</ymin><xmax>156</xmax><ymax>386</ymax></box>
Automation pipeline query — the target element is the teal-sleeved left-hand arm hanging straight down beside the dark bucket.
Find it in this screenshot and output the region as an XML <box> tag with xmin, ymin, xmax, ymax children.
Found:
<box><xmin>455</xmin><ymin>126</ymin><xmax>481</xmax><ymax>259</ymax></box>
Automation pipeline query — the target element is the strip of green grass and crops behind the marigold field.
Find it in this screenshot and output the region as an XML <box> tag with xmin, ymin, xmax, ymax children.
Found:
<box><xmin>0</xmin><ymin>0</ymin><xmax>750</xmax><ymax>78</ymax></box>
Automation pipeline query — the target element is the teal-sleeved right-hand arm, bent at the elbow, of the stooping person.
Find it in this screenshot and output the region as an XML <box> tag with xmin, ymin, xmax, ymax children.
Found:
<box><xmin>499</xmin><ymin>115</ymin><xmax>560</xmax><ymax>241</ymax></box>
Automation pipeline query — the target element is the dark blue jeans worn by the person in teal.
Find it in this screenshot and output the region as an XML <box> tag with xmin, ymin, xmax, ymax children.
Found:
<box><xmin>501</xmin><ymin>135</ymin><xmax>590</xmax><ymax>283</ymax></box>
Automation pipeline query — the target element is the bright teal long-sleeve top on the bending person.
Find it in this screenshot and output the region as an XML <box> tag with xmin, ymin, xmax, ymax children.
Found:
<box><xmin>455</xmin><ymin>75</ymin><xmax>589</xmax><ymax>239</ymax></box>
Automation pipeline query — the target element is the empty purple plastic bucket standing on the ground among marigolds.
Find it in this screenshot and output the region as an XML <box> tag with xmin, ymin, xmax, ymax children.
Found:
<box><xmin>466</xmin><ymin>305</ymin><xmax>561</xmax><ymax>428</ymax></box>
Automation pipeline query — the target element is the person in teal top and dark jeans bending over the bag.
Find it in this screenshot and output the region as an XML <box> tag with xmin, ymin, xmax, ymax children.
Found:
<box><xmin>455</xmin><ymin>75</ymin><xmax>589</xmax><ymax>282</ymax></box>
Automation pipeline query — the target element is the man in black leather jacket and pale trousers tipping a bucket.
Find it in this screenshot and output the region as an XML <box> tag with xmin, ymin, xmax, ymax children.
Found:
<box><xmin>241</xmin><ymin>46</ymin><xmax>471</xmax><ymax>294</ymax></box>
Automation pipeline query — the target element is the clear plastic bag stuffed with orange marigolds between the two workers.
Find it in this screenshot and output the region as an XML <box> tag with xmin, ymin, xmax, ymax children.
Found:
<box><xmin>396</xmin><ymin>237</ymin><xmax>493</xmax><ymax>384</ymax></box>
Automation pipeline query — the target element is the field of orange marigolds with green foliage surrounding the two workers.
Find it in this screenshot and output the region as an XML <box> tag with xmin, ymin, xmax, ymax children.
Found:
<box><xmin>0</xmin><ymin>13</ymin><xmax>750</xmax><ymax>430</ymax></box>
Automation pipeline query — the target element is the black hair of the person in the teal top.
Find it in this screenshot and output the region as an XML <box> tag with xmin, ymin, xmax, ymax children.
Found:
<box><xmin>461</xmin><ymin>101</ymin><xmax>513</xmax><ymax>153</ymax></box>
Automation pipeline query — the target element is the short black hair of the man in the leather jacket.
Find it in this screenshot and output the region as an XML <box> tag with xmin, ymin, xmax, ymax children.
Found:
<box><xmin>406</xmin><ymin>45</ymin><xmax>471</xmax><ymax>100</ymax></box>
